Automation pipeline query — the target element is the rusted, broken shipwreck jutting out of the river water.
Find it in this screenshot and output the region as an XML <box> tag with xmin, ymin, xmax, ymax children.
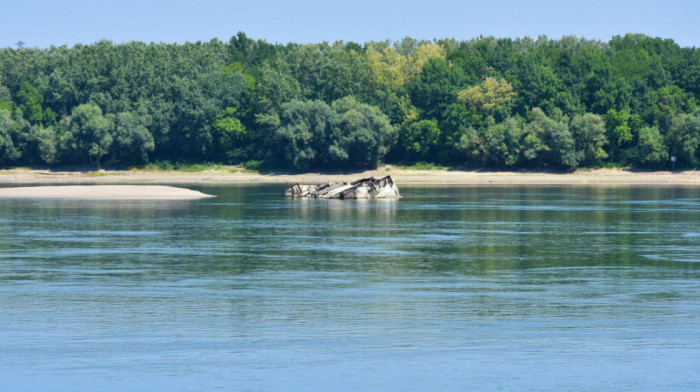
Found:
<box><xmin>285</xmin><ymin>176</ymin><xmax>401</xmax><ymax>199</ymax></box>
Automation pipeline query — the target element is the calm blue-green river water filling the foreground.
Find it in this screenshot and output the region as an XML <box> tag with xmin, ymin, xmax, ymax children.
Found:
<box><xmin>0</xmin><ymin>185</ymin><xmax>700</xmax><ymax>392</ymax></box>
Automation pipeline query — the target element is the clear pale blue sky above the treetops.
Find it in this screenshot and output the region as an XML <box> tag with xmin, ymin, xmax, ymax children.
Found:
<box><xmin>0</xmin><ymin>0</ymin><xmax>700</xmax><ymax>48</ymax></box>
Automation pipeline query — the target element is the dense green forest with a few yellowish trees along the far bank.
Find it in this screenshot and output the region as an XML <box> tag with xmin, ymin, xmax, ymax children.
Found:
<box><xmin>0</xmin><ymin>33</ymin><xmax>700</xmax><ymax>171</ymax></box>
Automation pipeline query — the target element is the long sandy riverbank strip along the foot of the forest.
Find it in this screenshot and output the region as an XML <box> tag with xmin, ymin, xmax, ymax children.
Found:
<box><xmin>0</xmin><ymin>166</ymin><xmax>700</xmax><ymax>186</ymax></box>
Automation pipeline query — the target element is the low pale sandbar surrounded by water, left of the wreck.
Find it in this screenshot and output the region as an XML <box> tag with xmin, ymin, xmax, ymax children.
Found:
<box><xmin>0</xmin><ymin>185</ymin><xmax>213</xmax><ymax>200</ymax></box>
